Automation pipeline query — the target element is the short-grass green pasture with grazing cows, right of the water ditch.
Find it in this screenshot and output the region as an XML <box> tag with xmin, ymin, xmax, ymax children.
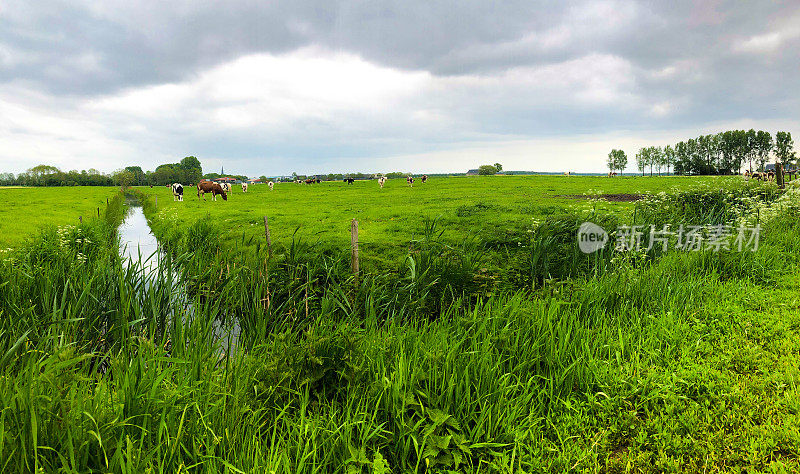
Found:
<box><xmin>139</xmin><ymin>176</ymin><xmax>732</xmax><ymax>258</ymax></box>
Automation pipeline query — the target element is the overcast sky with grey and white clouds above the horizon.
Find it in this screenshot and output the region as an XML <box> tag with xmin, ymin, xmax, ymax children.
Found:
<box><xmin>0</xmin><ymin>0</ymin><xmax>800</xmax><ymax>176</ymax></box>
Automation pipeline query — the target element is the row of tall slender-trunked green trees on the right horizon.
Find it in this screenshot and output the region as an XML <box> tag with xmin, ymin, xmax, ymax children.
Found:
<box><xmin>606</xmin><ymin>129</ymin><xmax>797</xmax><ymax>176</ymax></box>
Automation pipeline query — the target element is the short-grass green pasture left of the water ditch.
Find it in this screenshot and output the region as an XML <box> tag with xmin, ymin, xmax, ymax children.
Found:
<box><xmin>0</xmin><ymin>186</ymin><xmax>119</xmax><ymax>248</ymax></box>
